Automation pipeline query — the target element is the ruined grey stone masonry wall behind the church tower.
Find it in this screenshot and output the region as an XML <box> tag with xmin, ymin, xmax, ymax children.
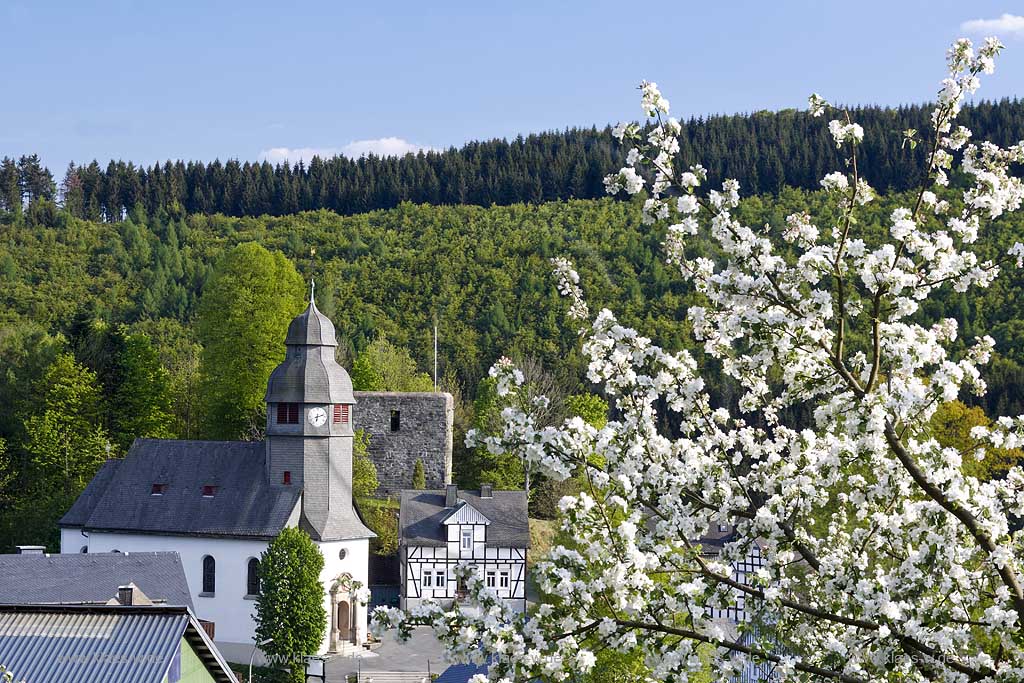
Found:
<box><xmin>352</xmin><ymin>391</ymin><xmax>455</xmax><ymax>496</ymax></box>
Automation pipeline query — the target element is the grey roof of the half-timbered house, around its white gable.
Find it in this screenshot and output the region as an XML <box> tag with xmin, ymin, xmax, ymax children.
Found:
<box><xmin>398</xmin><ymin>490</ymin><xmax>529</xmax><ymax>548</ymax></box>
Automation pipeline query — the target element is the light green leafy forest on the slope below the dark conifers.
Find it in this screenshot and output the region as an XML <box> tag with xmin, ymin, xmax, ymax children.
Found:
<box><xmin>0</xmin><ymin>188</ymin><xmax>1024</xmax><ymax>415</ymax></box>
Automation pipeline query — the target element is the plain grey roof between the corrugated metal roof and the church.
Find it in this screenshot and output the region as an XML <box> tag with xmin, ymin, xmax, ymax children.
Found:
<box><xmin>0</xmin><ymin>553</ymin><xmax>193</xmax><ymax>607</ymax></box>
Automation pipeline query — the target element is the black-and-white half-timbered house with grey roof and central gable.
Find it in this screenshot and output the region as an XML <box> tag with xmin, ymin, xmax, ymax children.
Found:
<box><xmin>398</xmin><ymin>484</ymin><xmax>529</xmax><ymax>610</ymax></box>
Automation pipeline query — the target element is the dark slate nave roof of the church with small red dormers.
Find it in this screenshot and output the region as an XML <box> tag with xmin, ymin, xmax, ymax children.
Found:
<box><xmin>60</xmin><ymin>439</ymin><xmax>301</xmax><ymax>539</ymax></box>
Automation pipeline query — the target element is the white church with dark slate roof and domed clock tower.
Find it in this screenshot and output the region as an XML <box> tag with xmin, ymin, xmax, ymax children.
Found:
<box><xmin>60</xmin><ymin>301</ymin><xmax>374</xmax><ymax>661</ymax></box>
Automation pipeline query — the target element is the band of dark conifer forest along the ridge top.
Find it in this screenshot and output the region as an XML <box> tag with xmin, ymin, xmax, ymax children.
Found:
<box><xmin>6</xmin><ymin>99</ymin><xmax>1024</xmax><ymax>221</ymax></box>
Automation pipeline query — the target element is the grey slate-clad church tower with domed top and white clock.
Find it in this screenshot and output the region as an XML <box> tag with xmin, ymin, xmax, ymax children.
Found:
<box><xmin>265</xmin><ymin>295</ymin><xmax>375</xmax><ymax>541</ymax></box>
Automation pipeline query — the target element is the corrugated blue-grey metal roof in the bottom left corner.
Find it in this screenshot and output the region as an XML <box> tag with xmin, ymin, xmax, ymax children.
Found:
<box><xmin>0</xmin><ymin>605</ymin><xmax>237</xmax><ymax>683</ymax></box>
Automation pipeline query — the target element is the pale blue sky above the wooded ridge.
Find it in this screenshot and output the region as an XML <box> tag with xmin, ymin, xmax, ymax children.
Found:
<box><xmin>6</xmin><ymin>0</ymin><xmax>1024</xmax><ymax>177</ymax></box>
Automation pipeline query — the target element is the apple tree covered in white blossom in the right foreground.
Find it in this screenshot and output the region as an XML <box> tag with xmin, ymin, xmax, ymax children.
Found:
<box><xmin>374</xmin><ymin>39</ymin><xmax>1024</xmax><ymax>683</ymax></box>
